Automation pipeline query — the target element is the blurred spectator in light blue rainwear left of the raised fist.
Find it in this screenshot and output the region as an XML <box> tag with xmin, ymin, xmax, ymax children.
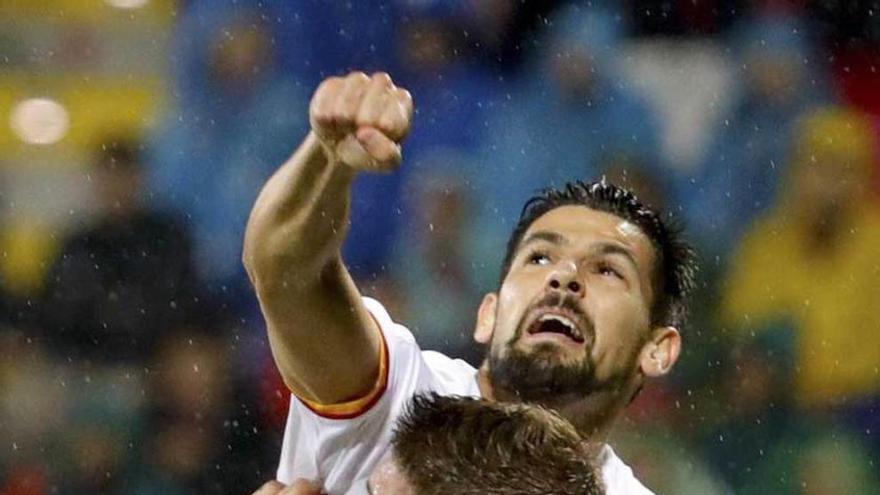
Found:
<box><xmin>149</xmin><ymin>2</ymin><xmax>309</xmax><ymax>296</ymax></box>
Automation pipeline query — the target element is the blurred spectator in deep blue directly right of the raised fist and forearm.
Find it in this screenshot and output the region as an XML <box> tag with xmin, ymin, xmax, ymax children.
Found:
<box><xmin>343</xmin><ymin>2</ymin><xmax>492</xmax><ymax>279</ymax></box>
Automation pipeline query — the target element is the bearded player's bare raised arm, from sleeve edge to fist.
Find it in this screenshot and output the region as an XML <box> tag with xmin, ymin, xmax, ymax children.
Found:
<box><xmin>243</xmin><ymin>72</ymin><xmax>412</xmax><ymax>404</ymax></box>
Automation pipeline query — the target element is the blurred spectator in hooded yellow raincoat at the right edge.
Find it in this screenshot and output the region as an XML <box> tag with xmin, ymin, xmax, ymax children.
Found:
<box><xmin>721</xmin><ymin>107</ymin><xmax>880</xmax><ymax>414</ymax></box>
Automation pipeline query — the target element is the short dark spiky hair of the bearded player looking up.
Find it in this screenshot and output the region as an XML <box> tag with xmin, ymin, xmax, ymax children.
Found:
<box><xmin>501</xmin><ymin>179</ymin><xmax>697</xmax><ymax>327</ymax></box>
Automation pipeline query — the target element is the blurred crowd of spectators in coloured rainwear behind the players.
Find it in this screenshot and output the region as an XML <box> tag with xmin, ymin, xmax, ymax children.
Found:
<box><xmin>0</xmin><ymin>0</ymin><xmax>880</xmax><ymax>495</ymax></box>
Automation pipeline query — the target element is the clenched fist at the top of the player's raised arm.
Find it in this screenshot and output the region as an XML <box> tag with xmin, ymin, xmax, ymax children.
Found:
<box><xmin>309</xmin><ymin>72</ymin><xmax>413</xmax><ymax>171</ymax></box>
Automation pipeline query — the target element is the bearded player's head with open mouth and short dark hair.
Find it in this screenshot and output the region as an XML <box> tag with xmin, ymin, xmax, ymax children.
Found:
<box><xmin>475</xmin><ymin>181</ymin><xmax>695</xmax><ymax>428</ymax></box>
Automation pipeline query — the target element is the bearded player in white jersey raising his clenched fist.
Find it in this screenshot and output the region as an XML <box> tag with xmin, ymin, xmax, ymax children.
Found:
<box><xmin>243</xmin><ymin>72</ymin><xmax>694</xmax><ymax>495</ymax></box>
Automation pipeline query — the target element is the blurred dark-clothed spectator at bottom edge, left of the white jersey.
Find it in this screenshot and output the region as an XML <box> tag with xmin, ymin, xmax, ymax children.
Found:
<box><xmin>128</xmin><ymin>325</ymin><xmax>264</xmax><ymax>495</ymax></box>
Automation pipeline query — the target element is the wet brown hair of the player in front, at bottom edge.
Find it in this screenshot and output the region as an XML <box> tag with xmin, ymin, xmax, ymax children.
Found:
<box><xmin>392</xmin><ymin>394</ymin><xmax>604</xmax><ymax>495</ymax></box>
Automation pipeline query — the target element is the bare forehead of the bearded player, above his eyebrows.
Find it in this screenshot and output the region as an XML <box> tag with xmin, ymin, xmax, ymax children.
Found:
<box><xmin>523</xmin><ymin>205</ymin><xmax>654</xmax><ymax>267</ymax></box>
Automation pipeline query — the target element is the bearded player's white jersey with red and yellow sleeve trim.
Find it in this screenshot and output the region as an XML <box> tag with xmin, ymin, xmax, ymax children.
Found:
<box><xmin>278</xmin><ymin>298</ymin><xmax>652</xmax><ymax>495</ymax></box>
